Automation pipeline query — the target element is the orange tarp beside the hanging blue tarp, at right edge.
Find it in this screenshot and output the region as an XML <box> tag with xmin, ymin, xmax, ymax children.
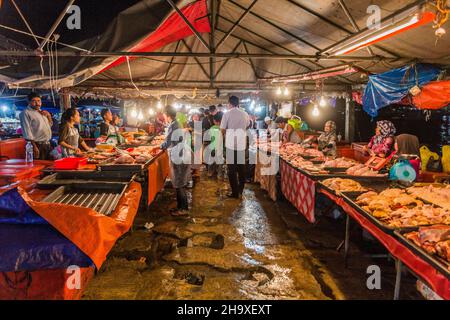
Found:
<box><xmin>413</xmin><ymin>80</ymin><xmax>450</xmax><ymax>109</ymax></box>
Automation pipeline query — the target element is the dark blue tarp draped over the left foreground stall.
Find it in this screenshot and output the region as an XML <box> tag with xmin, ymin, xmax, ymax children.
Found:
<box><xmin>0</xmin><ymin>189</ymin><xmax>94</xmax><ymax>272</ymax></box>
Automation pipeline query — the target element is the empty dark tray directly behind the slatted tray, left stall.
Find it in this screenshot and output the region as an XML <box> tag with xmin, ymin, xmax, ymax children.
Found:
<box><xmin>37</xmin><ymin>171</ymin><xmax>136</xmax><ymax>189</ymax></box>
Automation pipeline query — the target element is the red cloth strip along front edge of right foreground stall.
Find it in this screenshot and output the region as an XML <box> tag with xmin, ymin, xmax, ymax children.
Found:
<box><xmin>320</xmin><ymin>190</ymin><xmax>450</xmax><ymax>300</ymax></box>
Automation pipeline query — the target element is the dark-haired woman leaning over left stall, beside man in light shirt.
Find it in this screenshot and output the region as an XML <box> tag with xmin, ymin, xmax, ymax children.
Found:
<box><xmin>58</xmin><ymin>108</ymin><xmax>91</xmax><ymax>158</ymax></box>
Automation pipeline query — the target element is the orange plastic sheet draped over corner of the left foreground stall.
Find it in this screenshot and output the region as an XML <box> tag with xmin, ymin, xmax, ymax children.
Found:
<box><xmin>18</xmin><ymin>182</ymin><xmax>142</xmax><ymax>269</ymax></box>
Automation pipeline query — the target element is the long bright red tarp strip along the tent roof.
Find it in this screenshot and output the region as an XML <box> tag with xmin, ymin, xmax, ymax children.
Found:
<box><xmin>99</xmin><ymin>0</ymin><xmax>211</xmax><ymax>73</ymax></box>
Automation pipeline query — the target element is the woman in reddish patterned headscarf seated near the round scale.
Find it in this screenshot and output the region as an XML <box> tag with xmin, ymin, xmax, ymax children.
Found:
<box><xmin>364</xmin><ymin>120</ymin><xmax>397</xmax><ymax>158</ymax></box>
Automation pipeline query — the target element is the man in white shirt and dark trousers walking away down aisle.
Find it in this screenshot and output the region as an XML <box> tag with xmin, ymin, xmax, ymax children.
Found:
<box><xmin>220</xmin><ymin>96</ymin><xmax>249</xmax><ymax>199</ymax></box>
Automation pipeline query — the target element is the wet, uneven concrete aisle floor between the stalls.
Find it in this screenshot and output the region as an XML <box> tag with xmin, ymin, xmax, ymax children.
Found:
<box><xmin>83</xmin><ymin>171</ymin><xmax>420</xmax><ymax>300</ymax></box>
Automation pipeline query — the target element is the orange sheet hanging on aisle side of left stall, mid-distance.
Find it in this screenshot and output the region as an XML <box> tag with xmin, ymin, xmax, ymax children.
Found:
<box><xmin>147</xmin><ymin>151</ymin><xmax>169</xmax><ymax>205</ymax></box>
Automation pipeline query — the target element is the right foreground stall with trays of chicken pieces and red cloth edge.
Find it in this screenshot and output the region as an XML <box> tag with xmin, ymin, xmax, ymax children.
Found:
<box><xmin>318</xmin><ymin>185</ymin><xmax>450</xmax><ymax>300</ymax></box>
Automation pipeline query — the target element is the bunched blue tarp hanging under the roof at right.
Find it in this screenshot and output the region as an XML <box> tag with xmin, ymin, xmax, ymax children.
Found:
<box><xmin>363</xmin><ymin>64</ymin><xmax>442</xmax><ymax>117</ymax></box>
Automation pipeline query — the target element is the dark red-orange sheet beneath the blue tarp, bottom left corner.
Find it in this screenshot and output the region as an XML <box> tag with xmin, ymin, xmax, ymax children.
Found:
<box><xmin>0</xmin><ymin>267</ymin><xmax>95</xmax><ymax>300</ymax></box>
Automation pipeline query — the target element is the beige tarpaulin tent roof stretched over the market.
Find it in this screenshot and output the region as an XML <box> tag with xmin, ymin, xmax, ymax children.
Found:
<box><xmin>0</xmin><ymin>0</ymin><xmax>450</xmax><ymax>96</ymax></box>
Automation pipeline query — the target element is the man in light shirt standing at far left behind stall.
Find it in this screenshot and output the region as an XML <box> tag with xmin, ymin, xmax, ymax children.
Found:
<box><xmin>19</xmin><ymin>92</ymin><xmax>53</xmax><ymax>160</ymax></box>
